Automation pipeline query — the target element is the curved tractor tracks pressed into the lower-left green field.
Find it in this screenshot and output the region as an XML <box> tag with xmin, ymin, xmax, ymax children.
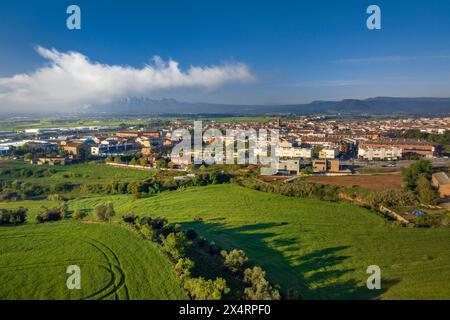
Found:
<box><xmin>0</xmin><ymin>233</ymin><xmax>131</xmax><ymax>300</ymax></box>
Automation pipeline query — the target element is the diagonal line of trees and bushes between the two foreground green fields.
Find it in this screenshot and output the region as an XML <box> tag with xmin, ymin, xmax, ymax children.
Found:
<box><xmin>122</xmin><ymin>214</ymin><xmax>281</xmax><ymax>300</ymax></box>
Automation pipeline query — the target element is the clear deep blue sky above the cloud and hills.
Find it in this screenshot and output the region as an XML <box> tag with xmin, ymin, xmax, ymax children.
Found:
<box><xmin>0</xmin><ymin>0</ymin><xmax>450</xmax><ymax>109</ymax></box>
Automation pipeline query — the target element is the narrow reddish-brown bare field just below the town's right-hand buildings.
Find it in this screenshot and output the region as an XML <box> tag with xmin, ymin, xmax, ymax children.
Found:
<box><xmin>306</xmin><ymin>173</ymin><xmax>402</xmax><ymax>190</ymax></box>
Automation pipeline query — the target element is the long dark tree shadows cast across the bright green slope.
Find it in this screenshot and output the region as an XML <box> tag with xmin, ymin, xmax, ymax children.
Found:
<box><xmin>179</xmin><ymin>220</ymin><xmax>399</xmax><ymax>299</ymax></box>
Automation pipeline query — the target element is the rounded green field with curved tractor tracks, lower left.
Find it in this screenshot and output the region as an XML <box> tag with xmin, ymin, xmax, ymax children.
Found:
<box><xmin>0</xmin><ymin>221</ymin><xmax>185</xmax><ymax>299</ymax></box>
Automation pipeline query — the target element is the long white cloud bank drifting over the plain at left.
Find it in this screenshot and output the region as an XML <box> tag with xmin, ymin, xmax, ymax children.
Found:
<box><xmin>0</xmin><ymin>47</ymin><xmax>255</xmax><ymax>112</ymax></box>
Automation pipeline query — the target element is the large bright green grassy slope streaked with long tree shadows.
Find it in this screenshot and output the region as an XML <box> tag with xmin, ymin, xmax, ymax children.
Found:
<box><xmin>63</xmin><ymin>185</ymin><xmax>450</xmax><ymax>299</ymax></box>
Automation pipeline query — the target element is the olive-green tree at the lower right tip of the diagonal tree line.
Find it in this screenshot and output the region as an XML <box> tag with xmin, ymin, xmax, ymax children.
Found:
<box><xmin>244</xmin><ymin>266</ymin><xmax>281</xmax><ymax>300</ymax></box>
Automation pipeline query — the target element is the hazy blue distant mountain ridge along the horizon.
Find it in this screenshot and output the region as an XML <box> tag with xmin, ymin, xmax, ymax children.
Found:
<box><xmin>86</xmin><ymin>97</ymin><xmax>450</xmax><ymax>116</ymax></box>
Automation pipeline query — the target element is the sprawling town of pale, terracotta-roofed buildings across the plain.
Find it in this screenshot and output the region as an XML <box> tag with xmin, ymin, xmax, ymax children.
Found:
<box><xmin>0</xmin><ymin>116</ymin><xmax>450</xmax><ymax>175</ymax></box>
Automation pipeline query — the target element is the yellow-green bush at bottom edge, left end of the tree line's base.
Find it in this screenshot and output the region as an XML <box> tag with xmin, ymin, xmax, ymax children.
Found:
<box><xmin>184</xmin><ymin>277</ymin><xmax>230</xmax><ymax>300</ymax></box>
